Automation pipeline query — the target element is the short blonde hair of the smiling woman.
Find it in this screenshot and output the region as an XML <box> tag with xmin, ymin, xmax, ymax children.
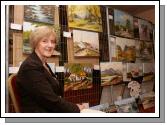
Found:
<box><xmin>29</xmin><ymin>26</ymin><xmax>56</xmax><ymax>50</ymax></box>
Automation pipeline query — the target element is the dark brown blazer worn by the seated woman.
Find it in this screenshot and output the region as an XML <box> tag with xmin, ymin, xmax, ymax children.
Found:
<box><xmin>16</xmin><ymin>52</ymin><xmax>80</xmax><ymax>113</ymax></box>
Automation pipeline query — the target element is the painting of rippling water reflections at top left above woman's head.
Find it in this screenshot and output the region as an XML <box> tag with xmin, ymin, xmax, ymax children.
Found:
<box><xmin>24</xmin><ymin>5</ymin><xmax>55</xmax><ymax>24</ymax></box>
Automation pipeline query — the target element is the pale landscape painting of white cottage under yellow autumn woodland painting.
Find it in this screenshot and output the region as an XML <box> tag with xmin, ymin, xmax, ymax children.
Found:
<box><xmin>73</xmin><ymin>30</ymin><xmax>99</xmax><ymax>57</ymax></box>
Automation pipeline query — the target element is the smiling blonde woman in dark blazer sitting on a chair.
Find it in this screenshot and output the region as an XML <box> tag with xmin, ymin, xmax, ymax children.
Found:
<box><xmin>16</xmin><ymin>26</ymin><xmax>84</xmax><ymax>113</ymax></box>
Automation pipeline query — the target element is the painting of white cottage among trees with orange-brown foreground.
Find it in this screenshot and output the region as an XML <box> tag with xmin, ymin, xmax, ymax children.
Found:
<box><xmin>64</xmin><ymin>63</ymin><xmax>93</xmax><ymax>91</ymax></box>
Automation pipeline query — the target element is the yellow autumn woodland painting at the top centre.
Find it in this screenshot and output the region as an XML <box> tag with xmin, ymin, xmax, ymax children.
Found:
<box><xmin>68</xmin><ymin>5</ymin><xmax>102</xmax><ymax>32</ymax></box>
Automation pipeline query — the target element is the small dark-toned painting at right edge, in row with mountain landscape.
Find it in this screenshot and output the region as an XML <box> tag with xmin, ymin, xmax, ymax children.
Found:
<box><xmin>143</xmin><ymin>63</ymin><xmax>155</xmax><ymax>82</ymax></box>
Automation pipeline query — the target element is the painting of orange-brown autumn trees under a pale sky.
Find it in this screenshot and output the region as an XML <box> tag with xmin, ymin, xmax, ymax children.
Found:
<box><xmin>115</xmin><ymin>37</ymin><xmax>136</xmax><ymax>62</ymax></box>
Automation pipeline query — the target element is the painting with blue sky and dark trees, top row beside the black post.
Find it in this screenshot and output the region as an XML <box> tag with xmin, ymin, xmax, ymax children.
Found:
<box><xmin>114</xmin><ymin>9</ymin><xmax>134</xmax><ymax>38</ymax></box>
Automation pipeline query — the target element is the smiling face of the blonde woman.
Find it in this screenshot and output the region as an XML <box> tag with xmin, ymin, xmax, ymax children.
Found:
<box><xmin>35</xmin><ymin>35</ymin><xmax>56</xmax><ymax>58</ymax></box>
